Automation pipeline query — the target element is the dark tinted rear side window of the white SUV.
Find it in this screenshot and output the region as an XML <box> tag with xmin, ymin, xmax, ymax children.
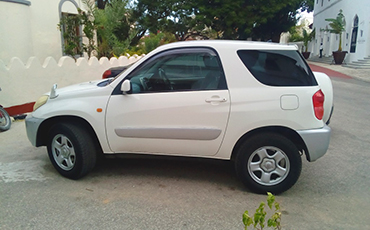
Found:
<box><xmin>238</xmin><ymin>50</ymin><xmax>317</xmax><ymax>86</ymax></box>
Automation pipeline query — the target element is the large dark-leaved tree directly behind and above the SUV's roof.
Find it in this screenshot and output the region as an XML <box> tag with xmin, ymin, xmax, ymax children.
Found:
<box><xmin>134</xmin><ymin>0</ymin><xmax>314</xmax><ymax>41</ymax></box>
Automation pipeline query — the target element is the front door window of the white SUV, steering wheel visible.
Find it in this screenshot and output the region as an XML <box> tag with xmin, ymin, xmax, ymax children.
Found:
<box><xmin>128</xmin><ymin>48</ymin><xmax>226</xmax><ymax>93</ymax></box>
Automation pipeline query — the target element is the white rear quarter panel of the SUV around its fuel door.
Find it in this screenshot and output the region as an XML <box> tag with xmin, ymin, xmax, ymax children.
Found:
<box><xmin>216</xmin><ymin>45</ymin><xmax>324</xmax><ymax>159</ymax></box>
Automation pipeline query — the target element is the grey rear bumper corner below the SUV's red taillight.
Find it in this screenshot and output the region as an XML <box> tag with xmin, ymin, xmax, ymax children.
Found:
<box><xmin>298</xmin><ymin>125</ymin><xmax>331</xmax><ymax>162</ymax></box>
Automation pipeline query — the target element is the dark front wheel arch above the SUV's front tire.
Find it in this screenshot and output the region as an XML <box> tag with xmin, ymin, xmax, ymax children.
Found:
<box><xmin>36</xmin><ymin>116</ymin><xmax>102</xmax><ymax>152</ymax></box>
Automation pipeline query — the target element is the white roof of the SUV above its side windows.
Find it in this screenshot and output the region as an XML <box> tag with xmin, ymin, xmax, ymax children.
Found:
<box><xmin>153</xmin><ymin>40</ymin><xmax>298</xmax><ymax>51</ymax></box>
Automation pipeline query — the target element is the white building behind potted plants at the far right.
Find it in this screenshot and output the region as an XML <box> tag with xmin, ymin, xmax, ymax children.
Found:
<box><xmin>312</xmin><ymin>0</ymin><xmax>370</xmax><ymax>63</ymax></box>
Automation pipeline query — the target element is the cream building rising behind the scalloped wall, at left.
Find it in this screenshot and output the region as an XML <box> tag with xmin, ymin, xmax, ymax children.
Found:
<box><xmin>0</xmin><ymin>0</ymin><xmax>91</xmax><ymax>64</ymax></box>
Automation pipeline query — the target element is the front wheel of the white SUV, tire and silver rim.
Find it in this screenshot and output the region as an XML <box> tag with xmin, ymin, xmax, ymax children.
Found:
<box><xmin>47</xmin><ymin>123</ymin><xmax>97</xmax><ymax>180</ymax></box>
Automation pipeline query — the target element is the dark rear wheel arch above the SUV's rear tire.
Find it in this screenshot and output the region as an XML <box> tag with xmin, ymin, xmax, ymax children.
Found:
<box><xmin>231</xmin><ymin>126</ymin><xmax>308</xmax><ymax>160</ymax></box>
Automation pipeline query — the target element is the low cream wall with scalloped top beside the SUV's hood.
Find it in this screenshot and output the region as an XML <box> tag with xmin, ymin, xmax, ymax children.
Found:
<box><xmin>0</xmin><ymin>55</ymin><xmax>141</xmax><ymax>107</ymax></box>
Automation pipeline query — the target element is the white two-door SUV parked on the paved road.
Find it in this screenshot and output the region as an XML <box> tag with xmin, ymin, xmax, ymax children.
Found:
<box><xmin>26</xmin><ymin>41</ymin><xmax>333</xmax><ymax>194</ymax></box>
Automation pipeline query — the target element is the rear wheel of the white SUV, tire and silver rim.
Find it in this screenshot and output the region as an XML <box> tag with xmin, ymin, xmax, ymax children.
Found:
<box><xmin>235</xmin><ymin>133</ymin><xmax>302</xmax><ymax>194</ymax></box>
